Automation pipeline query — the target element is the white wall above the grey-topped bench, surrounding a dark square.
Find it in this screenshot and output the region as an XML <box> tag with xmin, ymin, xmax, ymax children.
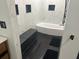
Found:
<box><xmin>15</xmin><ymin>0</ymin><xmax>40</xmax><ymax>33</ymax></box>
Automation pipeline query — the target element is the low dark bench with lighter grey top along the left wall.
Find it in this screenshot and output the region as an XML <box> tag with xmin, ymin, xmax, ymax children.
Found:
<box><xmin>20</xmin><ymin>29</ymin><xmax>37</xmax><ymax>59</ymax></box>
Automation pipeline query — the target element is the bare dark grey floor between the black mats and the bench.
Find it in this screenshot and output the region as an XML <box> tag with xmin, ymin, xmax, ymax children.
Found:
<box><xmin>25</xmin><ymin>33</ymin><xmax>58</xmax><ymax>59</ymax></box>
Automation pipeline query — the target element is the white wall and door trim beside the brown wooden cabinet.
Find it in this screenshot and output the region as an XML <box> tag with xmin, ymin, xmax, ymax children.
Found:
<box><xmin>0</xmin><ymin>0</ymin><xmax>21</xmax><ymax>59</ymax></box>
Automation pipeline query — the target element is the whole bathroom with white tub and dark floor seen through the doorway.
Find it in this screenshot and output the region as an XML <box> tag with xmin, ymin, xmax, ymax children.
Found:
<box><xmin>15</xmin><ymin>0</ymin><xmax>67</xmax><ymax>59</ymax></box>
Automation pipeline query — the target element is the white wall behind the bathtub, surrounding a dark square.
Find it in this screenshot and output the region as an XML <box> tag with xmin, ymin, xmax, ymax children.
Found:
<box><xmin>41</xmin><ymin>0</ymin><xmax>65</xmax><ymax>24</ymax></box>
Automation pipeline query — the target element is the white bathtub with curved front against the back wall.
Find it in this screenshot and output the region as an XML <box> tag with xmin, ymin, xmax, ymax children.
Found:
<box><xmin>36</xmin><ymin>23</ymin><xmax>64</xmax><ymax>36</ymax></box>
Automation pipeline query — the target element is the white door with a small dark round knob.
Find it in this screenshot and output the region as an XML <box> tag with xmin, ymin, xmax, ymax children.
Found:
<box><xmin>59</xmin><ymin>0</ymin><xmax>79</xmax><ymax>59</ymax></box>
